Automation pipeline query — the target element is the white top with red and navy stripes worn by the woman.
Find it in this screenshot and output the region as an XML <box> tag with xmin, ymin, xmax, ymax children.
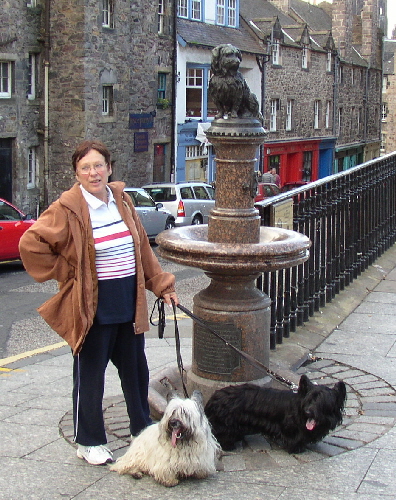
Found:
<box><xmin>80</xmin><ymin>186</ymin><xmax>136</xmax><ymax>280</ymax></box>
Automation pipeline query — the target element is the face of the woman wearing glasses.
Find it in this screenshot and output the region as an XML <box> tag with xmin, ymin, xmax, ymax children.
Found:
<box><xmin>76</xmin><ymin>149</ymin><xmax>111</xmax><ymax>202</ymax></box>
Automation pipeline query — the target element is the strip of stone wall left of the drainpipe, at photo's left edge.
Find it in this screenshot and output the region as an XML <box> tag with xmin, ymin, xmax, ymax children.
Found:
<box><xmin>0</xmin><ymin>0</ymin><xmax>43</xmax><ymax>213</ymax></box>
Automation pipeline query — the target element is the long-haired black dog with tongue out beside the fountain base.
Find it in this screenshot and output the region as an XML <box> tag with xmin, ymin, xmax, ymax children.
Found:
<box><xmin>205</xmin><ymin>375</ymin><xmax>346</xmax><ymax>453</ymax></box>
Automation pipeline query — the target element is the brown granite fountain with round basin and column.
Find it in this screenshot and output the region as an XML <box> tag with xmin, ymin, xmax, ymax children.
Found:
<box><xmin>153</xmin><ymin>46</ymin><xmax>310</xmax><ymax>400</ymax></box>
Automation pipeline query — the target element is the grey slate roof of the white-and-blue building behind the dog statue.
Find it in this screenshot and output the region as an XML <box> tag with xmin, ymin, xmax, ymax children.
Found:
<box><xmin>177</xmin><ymin>18</ymin><xmax>266</xmax><ymax>54</ymax></box>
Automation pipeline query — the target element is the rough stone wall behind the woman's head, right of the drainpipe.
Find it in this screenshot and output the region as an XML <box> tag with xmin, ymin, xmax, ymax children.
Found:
<box><xmin>46</xmin><ymin>0</ymin><xmax>172</xmax><ymax>203</ymax></box>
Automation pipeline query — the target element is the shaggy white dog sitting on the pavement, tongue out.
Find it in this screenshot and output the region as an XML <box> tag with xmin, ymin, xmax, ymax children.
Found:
<box><xmin>111</xmin><ymin>391</ymin><xmax>221</xmax><ymax>486</ymax></box>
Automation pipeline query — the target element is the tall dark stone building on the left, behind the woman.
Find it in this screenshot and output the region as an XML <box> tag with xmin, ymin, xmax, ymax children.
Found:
<box><xmin>0</xmin><ymin>0</ymin><xmax>174</xmax><ymax>212</ymax></box>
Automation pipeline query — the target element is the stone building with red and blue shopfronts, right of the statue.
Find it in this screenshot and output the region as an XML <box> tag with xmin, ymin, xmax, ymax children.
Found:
<box><xmin>242</xmin><ymin>0</ymin><xmax>382</xmax><ymax>183</ymax></box>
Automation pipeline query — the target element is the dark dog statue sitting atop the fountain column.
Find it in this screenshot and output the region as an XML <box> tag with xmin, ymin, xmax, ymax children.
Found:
<box><xmin>209</xmin><ymin>43</ymin><xmax>262</xmax><ymax>122</ymax></box>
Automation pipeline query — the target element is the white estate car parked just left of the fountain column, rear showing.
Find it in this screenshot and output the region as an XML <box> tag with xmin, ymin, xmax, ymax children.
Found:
<box><xmin>143</xmin><ymin>182</ymin><xmax>215</xmax><ymax>226</ymax></box>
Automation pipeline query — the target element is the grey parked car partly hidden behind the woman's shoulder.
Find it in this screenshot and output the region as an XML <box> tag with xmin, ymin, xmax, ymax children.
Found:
<box><xmin>124</xmin><ymin>187</ymin><xmax>175</xmax><ymax>241</ymax></box>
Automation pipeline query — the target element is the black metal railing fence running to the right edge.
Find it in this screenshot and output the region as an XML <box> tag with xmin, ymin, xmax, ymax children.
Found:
<box><xmin>256</xmin><ymin>153</ymin><xmax>396</xmax><ymax>349</ymax></box>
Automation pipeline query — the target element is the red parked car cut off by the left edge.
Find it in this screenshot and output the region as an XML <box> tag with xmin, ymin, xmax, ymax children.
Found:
<box><xmin>0</xmin><ymin>198</ymin><xmax>35</xmax><ymax>262</ymax></box>
